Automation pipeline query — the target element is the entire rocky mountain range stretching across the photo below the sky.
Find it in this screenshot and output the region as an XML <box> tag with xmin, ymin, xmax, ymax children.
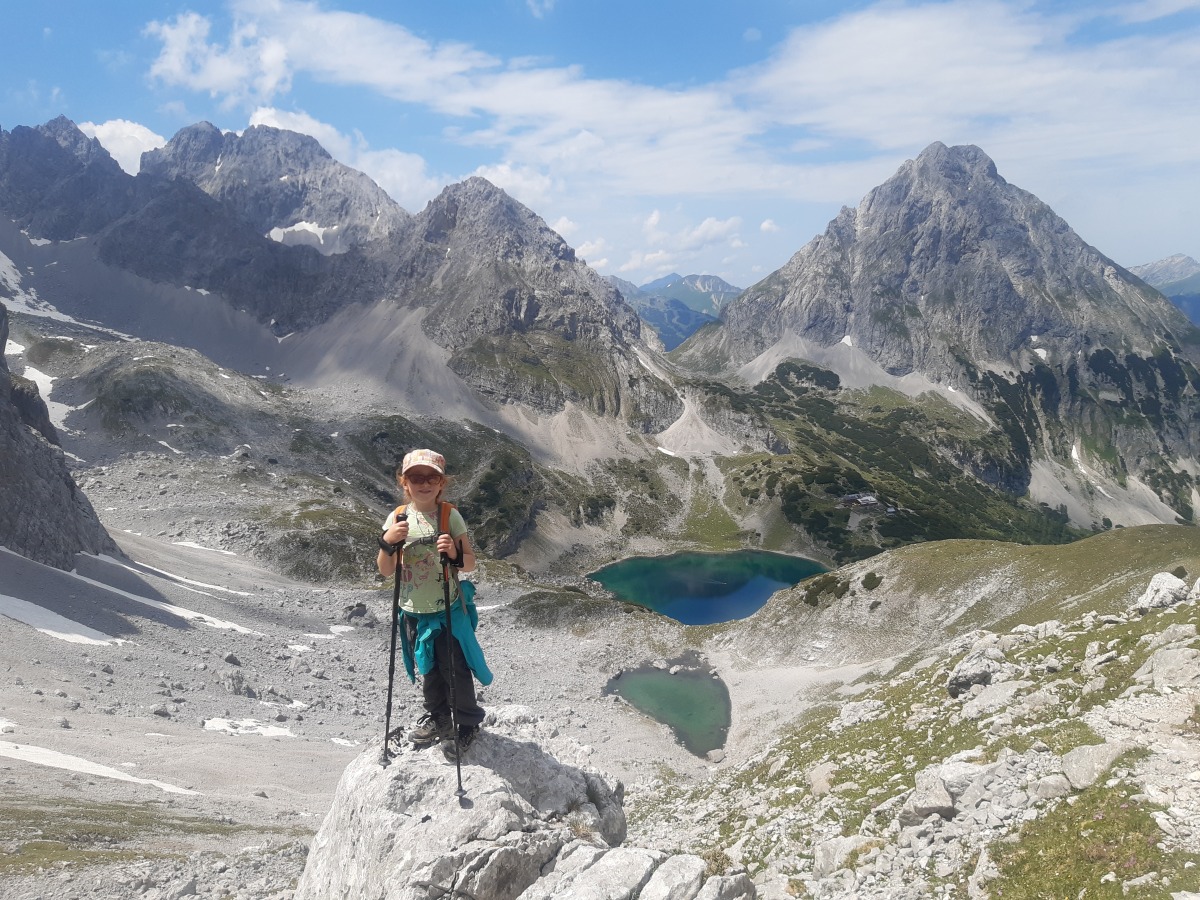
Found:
<box><xmin>0</xmin><ymin>119</ymin><xmax>1200</xmax><ymax>568</ymax></box>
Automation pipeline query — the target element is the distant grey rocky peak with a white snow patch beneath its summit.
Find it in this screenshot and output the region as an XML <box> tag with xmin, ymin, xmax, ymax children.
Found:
<box><xmin>142</xmin><ymin>122</ymin><xmax>409</xmax><ymax>254</ymax></box>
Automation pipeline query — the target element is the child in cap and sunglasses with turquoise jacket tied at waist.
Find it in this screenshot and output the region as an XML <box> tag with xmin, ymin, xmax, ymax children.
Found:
<box><xmin>376</xmin><ymin>450</ymin><xmax>492</xmax><ymax>760</ymax></box>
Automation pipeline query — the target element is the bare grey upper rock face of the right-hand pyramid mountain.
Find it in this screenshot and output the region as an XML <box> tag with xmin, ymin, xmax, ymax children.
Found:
<box><xmin>700</xmin><ymin>144</ymin><xmax>1190</xmax><ymax>377</ymax></box>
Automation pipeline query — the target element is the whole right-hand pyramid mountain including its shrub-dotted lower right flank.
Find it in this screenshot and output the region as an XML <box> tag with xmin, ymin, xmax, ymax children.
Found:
<box><xmin>679</xmin><ymin>144</ymin><xmax>1200</xmax><ymax>518</ymax></box>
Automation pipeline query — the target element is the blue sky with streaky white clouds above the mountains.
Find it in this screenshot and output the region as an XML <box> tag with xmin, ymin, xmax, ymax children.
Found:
<box><xmin>0</xmin><ymin>0</ymin><xmax>1200</xmax><ymax>287</ymax></box>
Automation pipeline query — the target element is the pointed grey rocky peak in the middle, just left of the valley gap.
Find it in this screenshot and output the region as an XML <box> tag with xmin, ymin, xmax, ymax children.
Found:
<box><xmin>390</xmin><ymin>178</ymin><xmax>679</xmax><ymax>431</ymax></box>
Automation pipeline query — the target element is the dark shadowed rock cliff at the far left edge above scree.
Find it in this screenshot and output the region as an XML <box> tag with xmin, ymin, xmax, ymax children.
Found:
<box><xmin>0</xmin><ymin>304</ymin><xmax>120</xmax><ymax>569</ymax></box>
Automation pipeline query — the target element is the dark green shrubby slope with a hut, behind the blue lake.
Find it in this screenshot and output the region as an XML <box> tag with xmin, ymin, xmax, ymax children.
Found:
<box><xmin>703</xmin><ymin>362</ymin><xmax>1084</xmax><ymax>563</ymax></box>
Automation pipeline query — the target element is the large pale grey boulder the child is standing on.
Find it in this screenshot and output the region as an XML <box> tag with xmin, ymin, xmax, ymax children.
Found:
<box><xmin>295</xmin><ymin>707</ymin><xmax>755</xmax><ymax>900</ymax></box>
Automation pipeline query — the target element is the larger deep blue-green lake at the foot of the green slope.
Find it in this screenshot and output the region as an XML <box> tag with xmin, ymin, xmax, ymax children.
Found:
<box><xmin>588</xmin><ymin>550</ymin><xmax>826</xmax><ymax>625</ymax></box>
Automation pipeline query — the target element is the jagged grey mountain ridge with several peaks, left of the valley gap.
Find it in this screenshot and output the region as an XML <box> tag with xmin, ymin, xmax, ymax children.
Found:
<box><xmin>0</xmin><ymin>118</ymin><xmax>679</xmax><ymax>432</ymax></box>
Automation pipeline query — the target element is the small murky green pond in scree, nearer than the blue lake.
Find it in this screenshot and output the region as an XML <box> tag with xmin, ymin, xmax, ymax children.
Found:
<box><xmin>605</xmin><ymin>652</ymin><xmax>733</xmax><ymax>757</ymax></box>
